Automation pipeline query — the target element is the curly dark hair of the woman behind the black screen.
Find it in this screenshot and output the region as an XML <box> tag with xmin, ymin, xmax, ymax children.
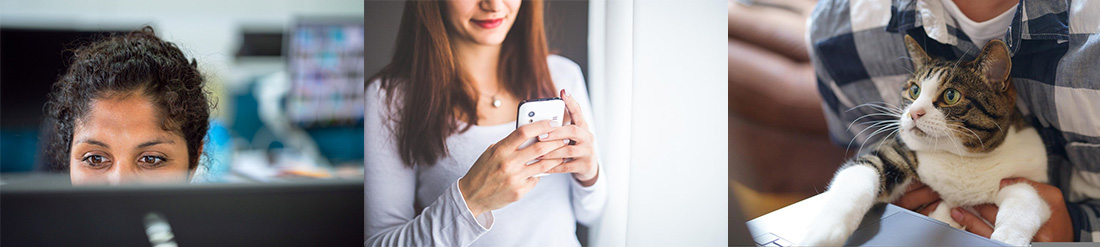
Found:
<box><xmin>45</xmin><ymin>26</ymin><xmax>213</xmax><ymax>171</ymax></box>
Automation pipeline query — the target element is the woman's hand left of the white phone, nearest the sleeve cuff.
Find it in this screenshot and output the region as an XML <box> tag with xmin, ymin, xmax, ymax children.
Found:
<box><xmin>459</xmin><ymin>121</ymin><xmax>565</xmax><ymax>215</ymax></box>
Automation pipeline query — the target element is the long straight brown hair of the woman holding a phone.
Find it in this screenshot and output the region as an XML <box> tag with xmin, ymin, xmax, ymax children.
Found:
<box><xmin>372</xmin><ymin>0</ymin><xmax>554</xmax><ymax>167</ymax></box>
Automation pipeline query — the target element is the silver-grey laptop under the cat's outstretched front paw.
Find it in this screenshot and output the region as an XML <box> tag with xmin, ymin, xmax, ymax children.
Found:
<box><xmin>746</xmin><ymin>194</ymin><xmax>1009</xmax><ymax>246</ymax></box>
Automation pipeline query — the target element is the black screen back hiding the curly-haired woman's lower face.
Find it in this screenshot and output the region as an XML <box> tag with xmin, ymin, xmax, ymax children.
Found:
<box><xmin>0</xmin><ymin>175</ymin><xmax>364</xmax><ymax>246</ymax></box>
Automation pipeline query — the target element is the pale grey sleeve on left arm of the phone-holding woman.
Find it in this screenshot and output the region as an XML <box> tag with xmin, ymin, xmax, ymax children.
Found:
<box><xmin>363</xmin><ymin>81</ymin><xmax>493</xmax><ymax>246</ymax></box>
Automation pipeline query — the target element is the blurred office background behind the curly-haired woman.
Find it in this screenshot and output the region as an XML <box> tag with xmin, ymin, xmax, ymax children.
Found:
<box><xmin>0</xmin><ymin>0</ymin><xmax>369</xmax><ymax>182</ymax></box>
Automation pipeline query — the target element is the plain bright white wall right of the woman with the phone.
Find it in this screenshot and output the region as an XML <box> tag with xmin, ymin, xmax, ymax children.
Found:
<box><xmin>626</xmin><ymin>0</ymin><xmax>729</xmax><ymax>246</ymax></box>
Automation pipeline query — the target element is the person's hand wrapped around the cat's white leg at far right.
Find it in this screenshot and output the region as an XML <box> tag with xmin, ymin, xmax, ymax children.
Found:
<box><xmin>952</xmin><ymin>178</ymin><xmax>1074</xmax><ymax>242</ymax></box>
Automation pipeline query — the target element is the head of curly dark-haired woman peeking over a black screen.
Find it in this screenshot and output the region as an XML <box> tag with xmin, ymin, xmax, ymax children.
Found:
<box><xmin>45</xmin><ymin>26</ymin><xmax>211</xmax><ymax>184</ymax></box>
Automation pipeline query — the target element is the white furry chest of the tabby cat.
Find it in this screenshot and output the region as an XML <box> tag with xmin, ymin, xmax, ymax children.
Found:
<box><xmin>916</xmin><ymin>128</ymin><xmax>1048</xmax><ymax>206</ymax></box>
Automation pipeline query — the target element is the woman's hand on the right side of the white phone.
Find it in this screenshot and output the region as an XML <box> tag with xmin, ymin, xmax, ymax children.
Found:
<box><xmin>539</xmin><ymin>89</ymin><xmax>600</xmax><ymax>187</ymax></box>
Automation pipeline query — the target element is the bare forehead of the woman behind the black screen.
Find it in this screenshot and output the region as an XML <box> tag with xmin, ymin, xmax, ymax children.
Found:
<box><xmin>73</xmin><ymin>94</ymin><xmax>183</xmax><ymax>144</ymax></box>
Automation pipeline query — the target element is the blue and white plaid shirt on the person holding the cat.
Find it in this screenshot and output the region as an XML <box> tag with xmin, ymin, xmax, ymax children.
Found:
<box><xmin>807</xmin><ymin>0</ymin><xmax>1100</xmax><ymax>242</ymax></box>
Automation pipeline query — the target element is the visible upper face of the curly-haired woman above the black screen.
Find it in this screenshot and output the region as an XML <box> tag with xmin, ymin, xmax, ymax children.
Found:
<box><xmin>69</xmin><ymin>93</ymin><xmax>191</xmax><ymax>184</ymax></box>
